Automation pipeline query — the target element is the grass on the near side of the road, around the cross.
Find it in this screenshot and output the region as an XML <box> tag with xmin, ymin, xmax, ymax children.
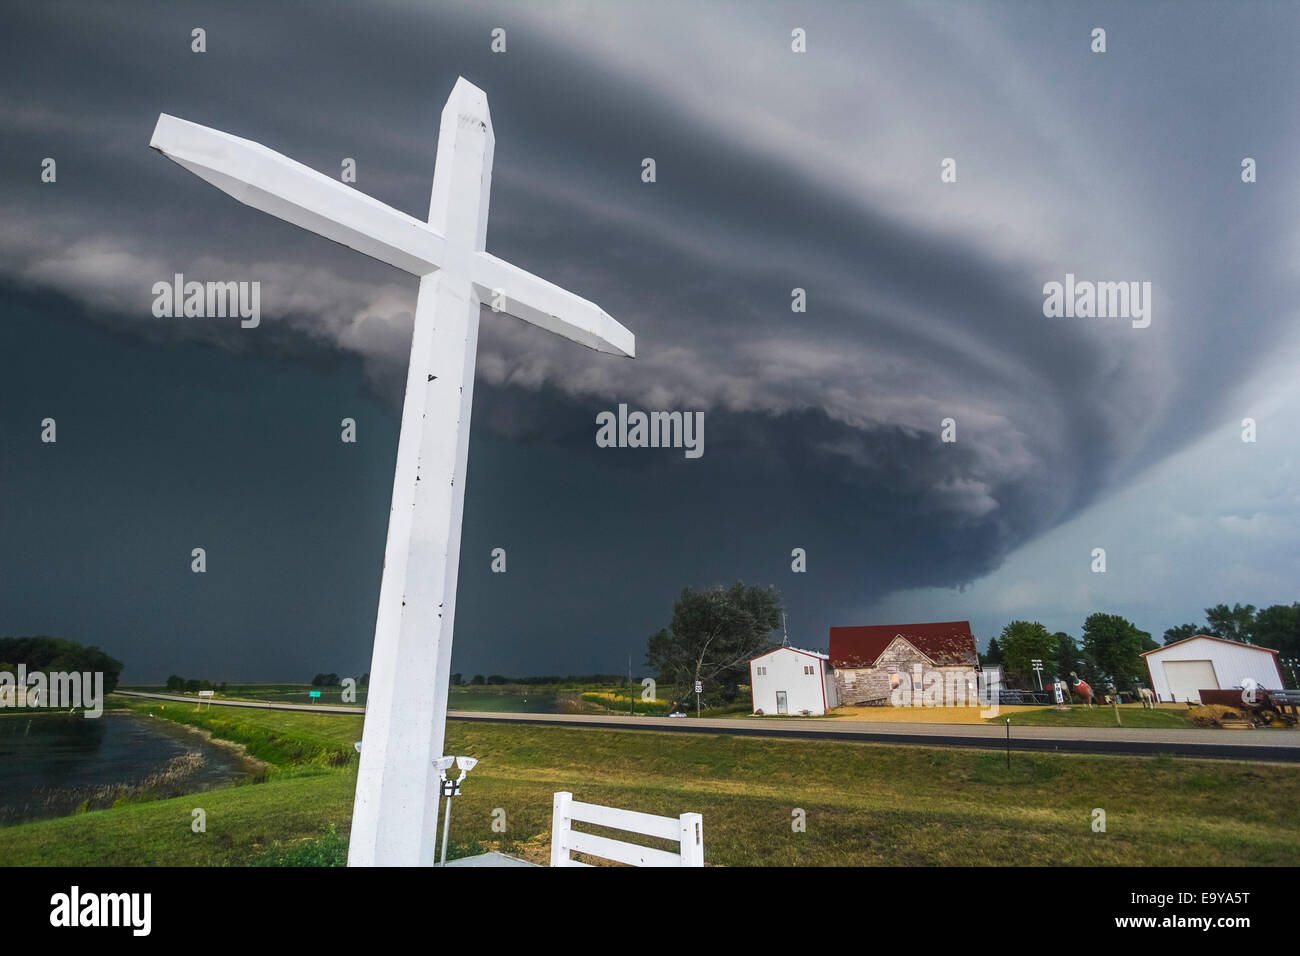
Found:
<box><xmin>0</xmin><ymin>702</ymin><xmax>1300</xmax><ymax>866</ymax></box>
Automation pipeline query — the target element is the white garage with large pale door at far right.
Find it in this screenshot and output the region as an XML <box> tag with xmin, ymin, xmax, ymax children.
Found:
<box><xmin>1143</xmin><ymin>633</ymin><xmax>1286</xmax><ymax>701</ymax></box>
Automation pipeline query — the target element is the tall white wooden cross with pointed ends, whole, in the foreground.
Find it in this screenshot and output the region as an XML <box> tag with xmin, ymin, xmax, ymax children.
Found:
<box><xmin>150</xmin><ymin>78</ymin><xmax>636</xmax><ymax>866</ymax></box>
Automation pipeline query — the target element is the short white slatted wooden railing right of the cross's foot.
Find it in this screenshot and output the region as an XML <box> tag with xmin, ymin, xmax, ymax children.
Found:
<box><xmin>551</xmin><ymin>791</ymin><xmax>705</xmax><ymax>866</ymax></box>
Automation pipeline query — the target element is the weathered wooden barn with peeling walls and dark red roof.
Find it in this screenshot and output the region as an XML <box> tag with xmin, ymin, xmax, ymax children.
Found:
<box><xmin>829</xmin><ymin>620</ymin><xmax>979</xmax><ymax>706</ymax></box>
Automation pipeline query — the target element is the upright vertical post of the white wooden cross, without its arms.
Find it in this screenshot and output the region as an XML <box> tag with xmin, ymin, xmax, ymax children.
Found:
<box><xmin>348</xmin><ymin>79</ymin><xmax>494</xmax><ymax>866</ymax></box>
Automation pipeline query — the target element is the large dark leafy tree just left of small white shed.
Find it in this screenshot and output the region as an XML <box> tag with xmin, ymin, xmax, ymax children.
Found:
<box><xmin>646</xmin><ymin>581</ymin><xmax>781</xmax><ymax>701</ymax></box>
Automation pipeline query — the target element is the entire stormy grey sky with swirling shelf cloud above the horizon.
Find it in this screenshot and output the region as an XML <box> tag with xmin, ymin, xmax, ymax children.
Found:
<box><xmin>0</xmin><ymin>3</ymin><xmax>1300</xmax><ymax>679</ymax></box>
